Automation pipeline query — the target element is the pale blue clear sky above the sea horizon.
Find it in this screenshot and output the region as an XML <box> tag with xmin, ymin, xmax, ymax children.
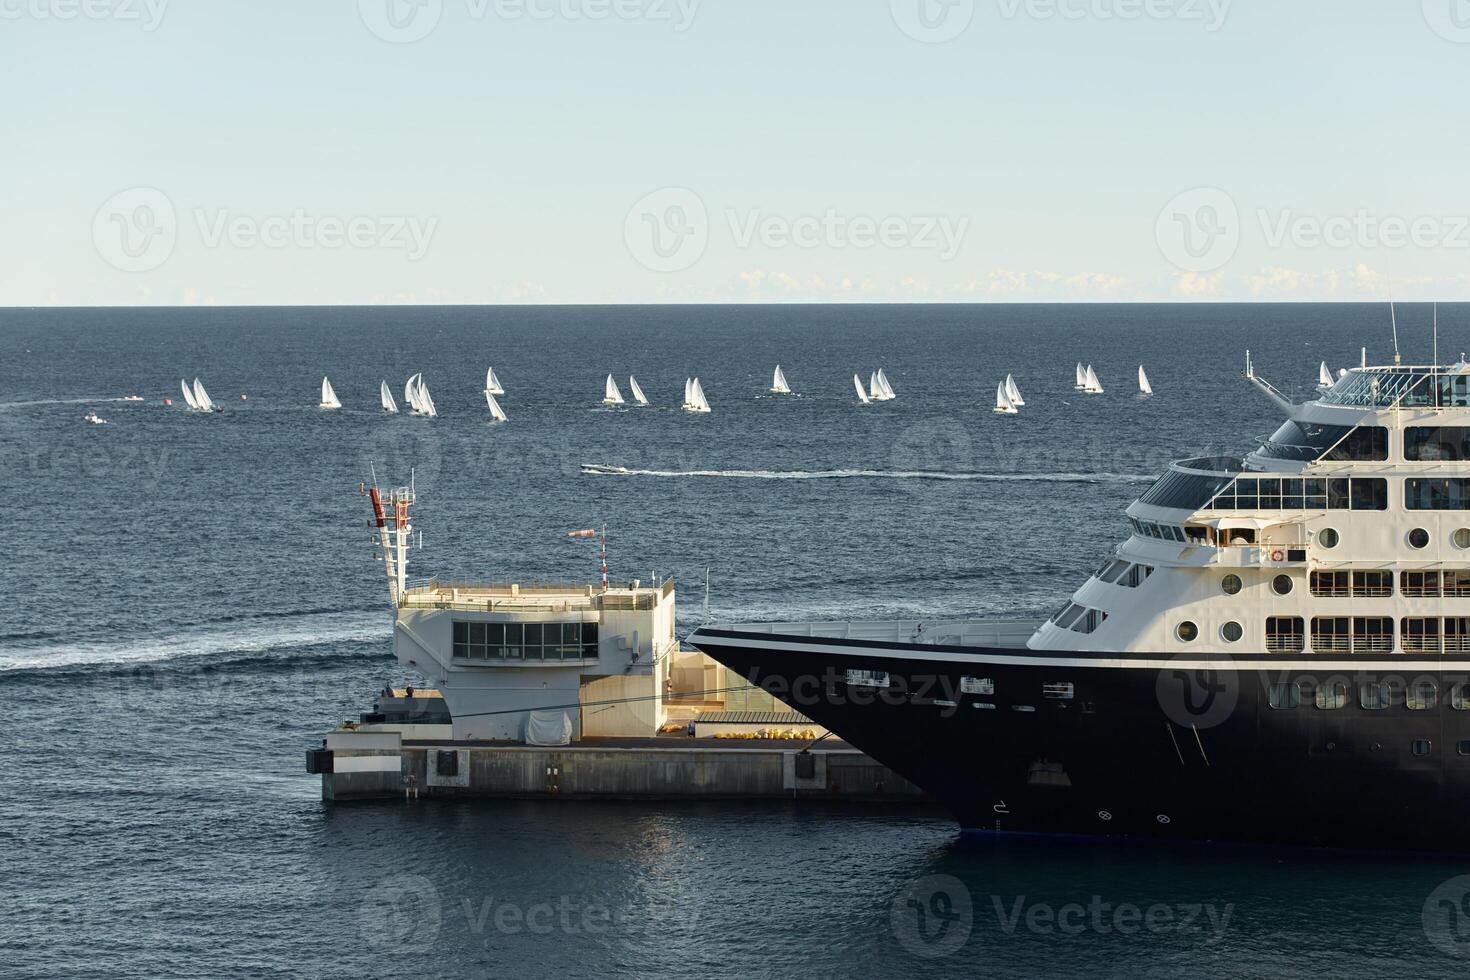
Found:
<box><xmin>0</xmin><ymin>0</ymin><xmax>1470</xmax><ymax>306</ymax></box>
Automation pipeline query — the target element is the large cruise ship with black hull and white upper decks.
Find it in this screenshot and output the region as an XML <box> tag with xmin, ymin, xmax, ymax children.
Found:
<box><xmin>691</xmin><ymin>356</ymin><xmax>1470</xmax><ymax>851</ymax></box>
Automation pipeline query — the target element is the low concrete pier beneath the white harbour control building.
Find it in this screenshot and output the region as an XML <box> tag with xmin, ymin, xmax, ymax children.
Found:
<box><xmin>307</xmin><ymin>732</ymin><xmax>929</xmax><ymax>804</ymax></box>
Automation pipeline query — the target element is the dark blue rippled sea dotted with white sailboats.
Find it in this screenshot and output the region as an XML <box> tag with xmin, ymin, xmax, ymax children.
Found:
<box><xmin>0</xmin><ymin>306</ymin><xmax>1470</xmax><ymax>979</ymax></box>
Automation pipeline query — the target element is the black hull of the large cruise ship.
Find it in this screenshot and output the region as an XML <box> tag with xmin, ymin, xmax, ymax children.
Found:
<box><xmin>692</xmin><ymin>629</ymin><xmax>1470</xmax><ymax>851</ymax></box>
